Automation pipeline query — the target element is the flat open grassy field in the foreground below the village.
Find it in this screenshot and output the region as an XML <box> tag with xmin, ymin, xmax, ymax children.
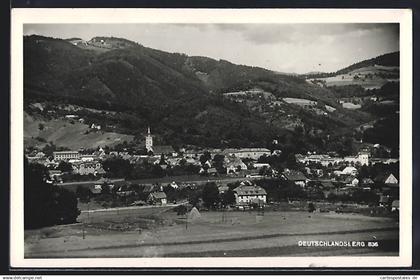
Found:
<box><xmin>25</xmin><ymin>206</ymin><xmax>398</xmax><ymax>258</ymax></box>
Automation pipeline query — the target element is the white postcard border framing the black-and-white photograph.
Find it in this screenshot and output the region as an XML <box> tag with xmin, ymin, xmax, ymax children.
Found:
<box><xmin>10</xmin><ymin>9</ymin><xmax>412</xmax><ymax>268</ymax></box>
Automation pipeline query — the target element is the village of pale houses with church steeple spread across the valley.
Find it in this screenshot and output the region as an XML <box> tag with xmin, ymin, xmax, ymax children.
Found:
<box><xmin>26</xmin><ymin>128</ymin><xmax>399</xmax><ymax>212</ymax></box>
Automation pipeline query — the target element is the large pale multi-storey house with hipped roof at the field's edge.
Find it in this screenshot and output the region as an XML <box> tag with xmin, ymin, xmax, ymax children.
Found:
<box><xmin>233</xmin><ymin>181</ymin><xmax>267</xmax><ymax>206</ymax></box>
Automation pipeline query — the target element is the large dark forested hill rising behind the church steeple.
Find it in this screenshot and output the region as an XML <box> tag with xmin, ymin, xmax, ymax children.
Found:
<box><xmin>24</xmin><ymin>35</ymin><xmax>389</xmax><ymax>154</ymax></box>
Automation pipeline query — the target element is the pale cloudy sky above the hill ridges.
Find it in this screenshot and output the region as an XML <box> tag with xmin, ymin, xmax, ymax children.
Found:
<box><xmin>23</xmin><ymin>23</ymin><xmax>399</xmax><ymax>74</ymax></box>
